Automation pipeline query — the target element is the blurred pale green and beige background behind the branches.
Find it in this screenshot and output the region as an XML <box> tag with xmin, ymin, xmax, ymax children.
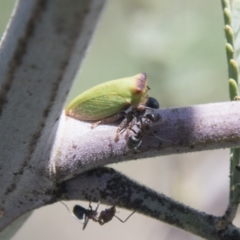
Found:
<box><xmin>0</xmin><ymin>0</ymin><xmax>236</xmax><ymax>240</ymax></box>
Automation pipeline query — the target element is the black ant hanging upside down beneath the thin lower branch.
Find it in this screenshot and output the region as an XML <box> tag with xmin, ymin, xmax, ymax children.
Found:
<box><xmin>61</xmin><ymin>202</ymin><xmax>135</xmax><ymax>230</ymax></box>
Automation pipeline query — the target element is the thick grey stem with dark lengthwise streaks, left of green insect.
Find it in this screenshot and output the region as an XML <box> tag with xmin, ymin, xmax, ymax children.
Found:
<box><xmin>0</xmin><ymin>0</ymin><xmax>104</xmax><ymax>236</ymax></box>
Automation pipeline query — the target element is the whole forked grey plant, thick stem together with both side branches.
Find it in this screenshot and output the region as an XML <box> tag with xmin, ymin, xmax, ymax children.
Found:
<box><xmin>0</xmin><ymin>0</ymin><xmax>240</xmax><ymax>239</ymax></box>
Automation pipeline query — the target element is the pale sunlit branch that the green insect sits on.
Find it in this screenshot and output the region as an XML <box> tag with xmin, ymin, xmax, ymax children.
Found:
<box><xmin>51</xmin><ymin>102</ymin><xmax>240</xmax><ymax>181</ymax></box>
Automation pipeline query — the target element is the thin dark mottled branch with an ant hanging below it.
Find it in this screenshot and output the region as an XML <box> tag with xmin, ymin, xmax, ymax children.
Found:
<box><xmin>62</xmin><ymin>168</ymin><xmax>240</xmax><ymax>240</ymax></box>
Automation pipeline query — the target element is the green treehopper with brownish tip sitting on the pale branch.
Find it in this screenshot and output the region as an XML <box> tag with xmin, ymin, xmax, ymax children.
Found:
<box><xmin>65</xmin><ymin>73</ymin><xmax>149</xmax><ymax>141</ymax></box>
